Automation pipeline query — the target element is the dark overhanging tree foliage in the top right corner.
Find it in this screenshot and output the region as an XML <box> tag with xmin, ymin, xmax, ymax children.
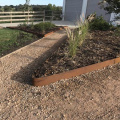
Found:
<box><xmin>99</xmin><ymin>0</ymin><xmax>120</xmax><ymax>19</ymax></box>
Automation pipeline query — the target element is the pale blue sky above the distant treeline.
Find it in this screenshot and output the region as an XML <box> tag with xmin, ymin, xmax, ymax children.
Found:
<box><xmin>0</xmin><ymin>0</ymin><xmax>63</xmax><ymax>6</ymax></box>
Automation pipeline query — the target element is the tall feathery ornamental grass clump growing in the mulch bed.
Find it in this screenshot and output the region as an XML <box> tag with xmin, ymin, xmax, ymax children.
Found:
<box><xmin>66</xmin><ymin>14</ymin><xmax>89</xmax><ymax>57</ymax></box>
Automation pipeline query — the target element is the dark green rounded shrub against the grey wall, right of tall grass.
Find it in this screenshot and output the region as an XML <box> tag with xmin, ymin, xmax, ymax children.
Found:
<box><xmin>89</xmin><ymin>16</ymin><xmax>111</xmax><ymax>31</ymax></box>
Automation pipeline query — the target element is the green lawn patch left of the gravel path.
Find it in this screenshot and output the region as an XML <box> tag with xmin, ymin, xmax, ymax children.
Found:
<box><xmin>0</xmin><ymin>28</ymin><xmax>37</xmax><ymax>56</ymax></box>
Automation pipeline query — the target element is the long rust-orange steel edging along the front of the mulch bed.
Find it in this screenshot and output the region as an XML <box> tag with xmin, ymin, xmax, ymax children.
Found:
<box><xmin>33</xmin><ymin>58</ymin><xmax>120</xmax><ymax>87</ymax></box>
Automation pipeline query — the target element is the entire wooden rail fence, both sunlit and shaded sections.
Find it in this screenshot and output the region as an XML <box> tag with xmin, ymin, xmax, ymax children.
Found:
<box><xmin>0</xmin><ymin>11</ymin><xmax>61</xmax><ymax>23</ymax></box>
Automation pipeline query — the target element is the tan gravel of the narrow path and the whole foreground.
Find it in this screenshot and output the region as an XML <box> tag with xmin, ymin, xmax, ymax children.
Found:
<box><xmin>0</xmin><ymin>29</ymin><xmax>120</xmax><ymax>120</ymax></box>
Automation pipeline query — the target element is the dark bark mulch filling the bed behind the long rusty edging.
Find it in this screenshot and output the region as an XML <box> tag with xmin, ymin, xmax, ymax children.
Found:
<box><xmin>33</xmin><ymin>31</ymin><xmax>120</xmax><ymax>78</ymax></box>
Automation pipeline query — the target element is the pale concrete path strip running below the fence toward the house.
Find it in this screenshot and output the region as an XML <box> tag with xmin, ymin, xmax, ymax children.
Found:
<box><xmin>0</xmin><ymin>21</ymin><xmax>76</xmax><ymax>28</ymax></box>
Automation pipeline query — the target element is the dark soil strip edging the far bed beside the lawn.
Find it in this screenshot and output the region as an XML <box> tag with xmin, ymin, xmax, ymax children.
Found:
<box><xmin>8</xmin><ymin>26</ymin><xmax>64</xmax><ymax>37</ymax></box>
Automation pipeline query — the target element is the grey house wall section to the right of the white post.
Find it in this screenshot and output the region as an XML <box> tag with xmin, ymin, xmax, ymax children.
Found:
<box><xmin>86</xmin><ymin>0</ymin><xmax>111</xmax><ymax>21</ymax></box>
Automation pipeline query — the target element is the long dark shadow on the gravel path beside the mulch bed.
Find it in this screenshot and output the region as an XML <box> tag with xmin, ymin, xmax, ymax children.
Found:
<box><xmin>11</xmin><ymin>36</ymin><xmax>67</xmax><ymax>85</ymax></box>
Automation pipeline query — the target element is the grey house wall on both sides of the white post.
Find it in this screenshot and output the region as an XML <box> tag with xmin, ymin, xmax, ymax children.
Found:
<box><xmin>64</xmin><ymin>0</ymin><xmax>111</xmax><ymax>21</ymax></box>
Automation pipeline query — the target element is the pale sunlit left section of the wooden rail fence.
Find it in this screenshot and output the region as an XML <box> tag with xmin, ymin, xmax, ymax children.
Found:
<box><xmin>0</xmin><ymin>11</ymin><xmax>45</xmax><ymax>23</ymax></box>
